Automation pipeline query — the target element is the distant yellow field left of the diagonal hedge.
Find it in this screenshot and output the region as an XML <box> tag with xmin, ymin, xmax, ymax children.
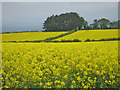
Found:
<box><xmin>2</xmin><ymin>32</ymin><xmax>67</xmax><ymax>41</ymax></box>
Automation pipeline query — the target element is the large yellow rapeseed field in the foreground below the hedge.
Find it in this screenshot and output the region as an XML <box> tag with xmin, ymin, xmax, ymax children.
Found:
<box><xmin>2</xmin><ymin>41</ymin><xmax>119</xmax><ymax>88</ymax></box>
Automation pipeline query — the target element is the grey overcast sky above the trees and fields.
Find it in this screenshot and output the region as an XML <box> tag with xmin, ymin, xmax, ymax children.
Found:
<box><xmin>2</xmin><ymin>2</ymin><xmax>118</xmax><ymax>32</ymax></box>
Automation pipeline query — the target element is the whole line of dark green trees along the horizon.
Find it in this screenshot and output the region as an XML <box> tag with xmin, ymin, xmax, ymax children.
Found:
<box><xmin>43</xmin><ymin>12</ymin><xmax>120</xmax><ymax>32</ymax></box>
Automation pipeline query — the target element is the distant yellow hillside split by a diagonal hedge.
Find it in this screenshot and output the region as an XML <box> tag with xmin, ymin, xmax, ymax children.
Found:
<box><xmin>2</xmin><ymin>29</ymin><xmax>118</xmax><ymax>42</ymax></box>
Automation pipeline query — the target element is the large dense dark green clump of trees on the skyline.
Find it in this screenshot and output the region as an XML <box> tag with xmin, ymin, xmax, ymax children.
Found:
<box><xmin>43</xmin><ymin>12</ymin><xmax>88</xmax><ymax>32</ymax></box>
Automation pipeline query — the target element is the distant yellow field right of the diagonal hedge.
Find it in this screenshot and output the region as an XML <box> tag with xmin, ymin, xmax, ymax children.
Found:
<box><xmin>55</xmin><ymin>29</ymin><xmax>118</xmax><ymax>41</ymax></box>
